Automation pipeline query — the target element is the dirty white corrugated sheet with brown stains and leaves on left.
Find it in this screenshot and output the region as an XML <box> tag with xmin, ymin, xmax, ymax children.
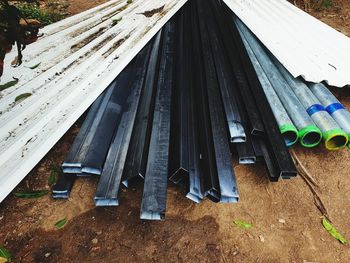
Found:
<box><xmin>0</xmin><ymin>0</ymin><xmax>187</xmax><ymax>202</ymax></box>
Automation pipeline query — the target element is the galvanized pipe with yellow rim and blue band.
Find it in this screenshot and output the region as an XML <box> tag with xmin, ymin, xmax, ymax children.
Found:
<box><xmin>269</xmin><ymin>59</ymin><xmax>348</xmax><ymax>150</ymax></box>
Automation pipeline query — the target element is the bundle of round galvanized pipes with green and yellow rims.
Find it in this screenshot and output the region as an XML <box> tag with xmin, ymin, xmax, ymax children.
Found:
<box><xmin>234</xmin><ymin>17</ymin><xmax>350</xmax><ymax>150</ymax></box>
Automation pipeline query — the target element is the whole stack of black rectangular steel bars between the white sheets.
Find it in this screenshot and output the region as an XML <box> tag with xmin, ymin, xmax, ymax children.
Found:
<box><xmin>53</xmin><ymin>0</ymin><xmax>297</xmax><ymax>219</ymax></box>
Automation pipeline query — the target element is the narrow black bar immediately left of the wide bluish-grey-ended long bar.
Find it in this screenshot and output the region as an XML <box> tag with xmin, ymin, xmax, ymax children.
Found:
<box><xmin>190</xmin><ymin>2</ymin><xmax>220</xmax><ymax>202</ymax></box>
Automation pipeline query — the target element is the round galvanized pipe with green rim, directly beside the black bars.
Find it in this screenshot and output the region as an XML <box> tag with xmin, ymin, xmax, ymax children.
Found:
<box><xmin>240</xmin><ymin>29</ymin><xmax>299</xmax><ymax>146</ymax></box>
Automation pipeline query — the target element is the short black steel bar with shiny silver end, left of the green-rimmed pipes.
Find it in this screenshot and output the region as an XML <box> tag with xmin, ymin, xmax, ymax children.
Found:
<box><xmin>204</xmin><ymin>3</ymin><xmax>246</xmax><ymax>143</ymax></box>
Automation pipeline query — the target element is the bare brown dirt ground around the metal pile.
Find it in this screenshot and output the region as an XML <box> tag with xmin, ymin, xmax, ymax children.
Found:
<box><xmin>0</xmin><ymin>0</ymin><xmax>350</xmax><ymax>263</ymax></box>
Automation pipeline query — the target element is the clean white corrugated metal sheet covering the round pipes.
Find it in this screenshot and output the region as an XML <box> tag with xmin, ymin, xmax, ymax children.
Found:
<box><xmin>224</xmin><ymin>0</ymin><xmax>350</xmax><ymax>87</ymax></box>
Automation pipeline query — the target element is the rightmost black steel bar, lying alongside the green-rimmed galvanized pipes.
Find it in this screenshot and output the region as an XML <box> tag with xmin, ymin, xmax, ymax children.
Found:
<box><xmin>225</xmin><ymin>9</ymin><xmax>297</xmax><ymax>180</ymax></box>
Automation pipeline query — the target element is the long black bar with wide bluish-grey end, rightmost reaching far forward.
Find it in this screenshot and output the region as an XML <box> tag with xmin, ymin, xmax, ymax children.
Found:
<box><xmin>196</xmin><ymin>0</ymin><xmax>239</xmax><ymax>203</ymax></box>
